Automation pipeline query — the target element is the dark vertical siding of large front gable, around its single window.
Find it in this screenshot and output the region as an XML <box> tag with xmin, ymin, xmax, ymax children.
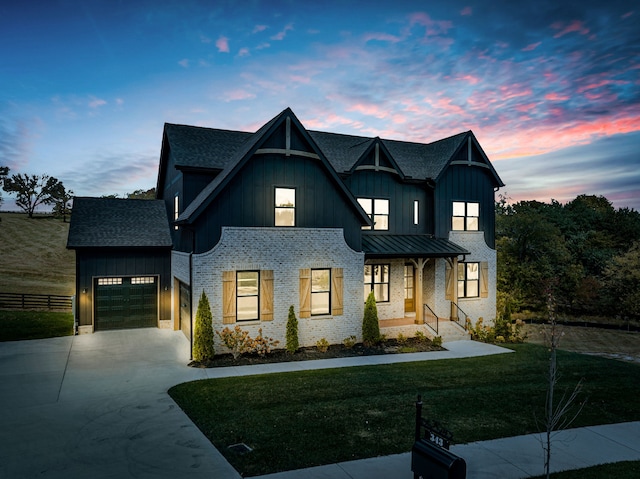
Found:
<box><xmin>188</xmin><ymin>154</ymin><xmax>361</xmax><ymax>253</ymax></box>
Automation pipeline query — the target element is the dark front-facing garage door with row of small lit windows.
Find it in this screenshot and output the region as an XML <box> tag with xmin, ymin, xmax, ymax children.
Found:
<box><xmin>95</xmin><ymin>276</ymin><xmax>158</xmax><ymax>331</ymax></box>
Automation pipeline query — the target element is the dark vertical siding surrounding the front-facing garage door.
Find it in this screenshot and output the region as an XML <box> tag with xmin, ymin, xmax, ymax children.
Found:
<box><xmin>76</xmin><ymin>248</ymin><xmax>171</xmax><ymax>326</ymax></box>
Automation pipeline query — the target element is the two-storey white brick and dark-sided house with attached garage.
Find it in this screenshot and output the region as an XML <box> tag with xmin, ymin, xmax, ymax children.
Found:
<box><xmin>68</xmin><ymin>108</ymin><xmax>504</xmax><ymax>346</ymax></box>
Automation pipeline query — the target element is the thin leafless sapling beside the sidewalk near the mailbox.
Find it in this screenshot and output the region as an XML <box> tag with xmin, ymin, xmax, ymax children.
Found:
<box><xmin>541</xmin><ymin>288</ymin><xmax>585</xmax><ymax>479</ymax></box>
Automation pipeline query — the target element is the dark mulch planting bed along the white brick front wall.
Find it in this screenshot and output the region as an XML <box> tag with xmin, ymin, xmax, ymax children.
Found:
<box><xmin>189</xmin><ymin>338</ymin><xmax>445</xmax><ymax>368</ymax></box>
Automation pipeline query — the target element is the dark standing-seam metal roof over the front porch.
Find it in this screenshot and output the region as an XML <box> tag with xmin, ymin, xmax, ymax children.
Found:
<box><xmin>362</xmin><ymin>234</ymin><xmax>470</xmax><ymax>258</ymax></box>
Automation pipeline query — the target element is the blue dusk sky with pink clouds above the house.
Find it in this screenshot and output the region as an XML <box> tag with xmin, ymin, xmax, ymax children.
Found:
<box><xmin>0</xmin><ymin>0</ymin><xmax>640</xmax><ymax>210</ymax></box>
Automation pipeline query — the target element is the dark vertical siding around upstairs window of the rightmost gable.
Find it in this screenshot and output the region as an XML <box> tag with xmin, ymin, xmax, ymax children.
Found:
<box><xmin>435</xmin><ymin>163</ymin><xmax>495</xmax><ymax>249</ymax></box>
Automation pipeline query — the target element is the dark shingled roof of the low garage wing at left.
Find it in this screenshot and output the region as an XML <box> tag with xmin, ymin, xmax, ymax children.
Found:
<box><xmin>67</xmin><ymin>197</ymin><xmax>173</xmax><ymax>249</ymax></box>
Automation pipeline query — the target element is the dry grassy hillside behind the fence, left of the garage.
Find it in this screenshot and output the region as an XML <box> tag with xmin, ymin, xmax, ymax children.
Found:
<box><xmin>0</xmin><ymin>213</ymin><xmax>76</xmax><ymax>295</ymax></box>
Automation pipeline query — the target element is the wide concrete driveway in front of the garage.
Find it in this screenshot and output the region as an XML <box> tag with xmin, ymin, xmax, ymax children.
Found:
<box><xmin>0</xmin><ymin>329</ymin><xmax>240</xmax><ymax>479</ymax></box>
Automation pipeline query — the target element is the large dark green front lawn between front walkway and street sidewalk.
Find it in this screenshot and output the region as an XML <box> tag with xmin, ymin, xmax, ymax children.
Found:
<box><xmin>169</xmin><ymin>344</ymin><xmax>640</xmax><ymax>475</ymax></box>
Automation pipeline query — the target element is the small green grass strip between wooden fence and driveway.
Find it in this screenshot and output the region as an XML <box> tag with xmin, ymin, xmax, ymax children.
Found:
<box><xmin>0</xmin><ymin>310</ymin><xmax>73</xmax><ymax>341</ymax></box>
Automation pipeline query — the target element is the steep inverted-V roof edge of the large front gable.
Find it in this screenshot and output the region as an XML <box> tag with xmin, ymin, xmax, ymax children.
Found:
<box><xmin>176</xmin><ymin>108</ymin><xmax>371</xmax><ymax>224</ymax></box>
